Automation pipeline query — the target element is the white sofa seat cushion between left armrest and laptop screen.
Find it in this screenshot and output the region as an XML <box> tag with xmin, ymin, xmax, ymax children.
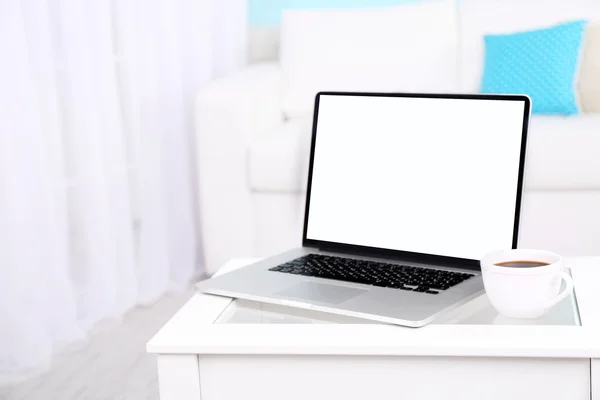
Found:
<box><xmin>248</xmin><ymin>117</ymin><xmax>312</xmax><ymax>193</ymax></box>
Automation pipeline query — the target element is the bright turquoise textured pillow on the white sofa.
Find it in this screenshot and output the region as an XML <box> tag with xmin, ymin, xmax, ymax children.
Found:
<box><xmin>481</xmin><ymin>21</ymin><xmax>587</xmax><ymax>115</ymax></box>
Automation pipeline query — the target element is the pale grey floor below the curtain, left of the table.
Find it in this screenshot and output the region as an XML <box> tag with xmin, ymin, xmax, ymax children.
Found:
<box><xmin>0</xmin><ymin>291</ymin><xmax>192</xmax><ymax>400</ymax></box>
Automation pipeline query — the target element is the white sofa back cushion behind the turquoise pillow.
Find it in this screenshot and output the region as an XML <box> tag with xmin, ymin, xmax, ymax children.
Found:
<box><xmin>458</xmin><ymin>0</ymin><xmax>600</xmax><ymax>93</ymax></box>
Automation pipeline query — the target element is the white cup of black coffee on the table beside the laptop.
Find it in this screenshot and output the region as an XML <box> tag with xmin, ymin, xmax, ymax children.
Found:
<box><xmin>481</xmin><ymin>249</ymin><xmax>573</xmax><ymax>318</ymax></box>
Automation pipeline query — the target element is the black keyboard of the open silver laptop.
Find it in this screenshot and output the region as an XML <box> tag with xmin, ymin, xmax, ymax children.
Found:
<box><xmin>269</xmin><ymin>254</ymin><xmax>475</xmax><ymax>294</ymax></box>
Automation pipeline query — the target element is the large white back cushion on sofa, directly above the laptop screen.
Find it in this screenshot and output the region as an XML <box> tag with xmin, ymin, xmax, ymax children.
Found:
<box><xmin>280</xmin><ymin>0</ymin><xmax>460</xmax><ymax>117</ymax></box>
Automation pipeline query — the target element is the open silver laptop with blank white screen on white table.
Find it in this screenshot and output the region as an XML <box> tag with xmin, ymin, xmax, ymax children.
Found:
<box><xmin>197</xmin><ymin>92</ymin><xmax>530</xmax><ymax>327</ymax></box>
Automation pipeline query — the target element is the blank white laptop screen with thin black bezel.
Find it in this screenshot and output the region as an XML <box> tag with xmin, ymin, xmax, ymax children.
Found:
<box><xmin>305</xmin><ymin>94</ymin><xmax>529</xmax><ymax>260</ymax></box>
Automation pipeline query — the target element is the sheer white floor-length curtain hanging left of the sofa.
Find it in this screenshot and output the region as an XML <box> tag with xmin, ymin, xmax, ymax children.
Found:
<box><xmin>0</xmin><ymin>0</ymin><xmax>247</xmax><ymax>384</ymax></box>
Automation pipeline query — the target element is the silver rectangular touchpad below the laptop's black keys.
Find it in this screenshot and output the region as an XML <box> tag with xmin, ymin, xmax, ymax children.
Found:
<box><xmin>277</xmin><ymin>282</ymin><xmax>367</xmax><ymax>304</ymax></box>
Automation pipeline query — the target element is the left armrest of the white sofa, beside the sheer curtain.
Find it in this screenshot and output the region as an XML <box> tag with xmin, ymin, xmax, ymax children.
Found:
<box><xmin>195</xmin><ymin>62</ymin><xmax>284</xmax><ymax>275</ymax></box>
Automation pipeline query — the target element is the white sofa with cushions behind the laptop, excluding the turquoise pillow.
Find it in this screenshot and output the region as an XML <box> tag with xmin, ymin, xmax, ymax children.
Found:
<box><xmin>196</xmin><ymin>0</ymin><xmax>600</xmax><ymax>273</ymax></box>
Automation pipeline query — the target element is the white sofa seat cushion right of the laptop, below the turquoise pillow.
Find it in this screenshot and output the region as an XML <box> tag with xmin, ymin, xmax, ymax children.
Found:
<box><xmin>525</xmin><ymin>114</ymin><xmax>600</xmax><ymax>190</ymax></box>
